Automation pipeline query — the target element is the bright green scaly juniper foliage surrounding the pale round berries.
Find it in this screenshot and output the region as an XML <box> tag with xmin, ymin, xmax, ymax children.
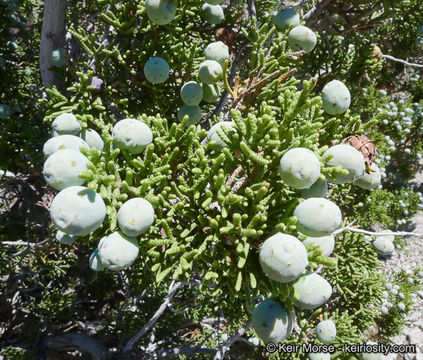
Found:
<box><xmin>0</xmin><ymin>0</ymin><xmax>423</xmax><ymax>359</ymax></box>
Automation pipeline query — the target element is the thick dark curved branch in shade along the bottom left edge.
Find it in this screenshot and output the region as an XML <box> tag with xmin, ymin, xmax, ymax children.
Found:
<box><xmin>42</xmin><ymin>334</ymin><xmax>110</xmax><ymax>360</ymax></box>
